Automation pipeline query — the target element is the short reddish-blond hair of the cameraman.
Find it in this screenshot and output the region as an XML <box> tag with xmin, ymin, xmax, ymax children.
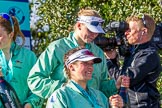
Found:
<box><xmin>126</xmin><ymin>14</ymin><xmax>155</xmax><ymax>39</ymax></box>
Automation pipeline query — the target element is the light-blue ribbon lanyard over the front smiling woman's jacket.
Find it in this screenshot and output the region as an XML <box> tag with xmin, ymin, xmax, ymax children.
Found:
<box><xmin>72</xmin><ymin>81</ymin><xmax>100</xmax><ymax>108</ymax></box>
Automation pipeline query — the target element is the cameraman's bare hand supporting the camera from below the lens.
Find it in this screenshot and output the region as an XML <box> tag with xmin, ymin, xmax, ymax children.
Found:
<box><xmin>104</xmin><ymin>49</ymin><xmax>117</xmax><ymax>59</ymax></box>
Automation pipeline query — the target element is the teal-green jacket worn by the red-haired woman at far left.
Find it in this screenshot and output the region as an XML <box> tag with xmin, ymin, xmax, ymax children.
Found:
<box><xmin>0</xmin><ymin>42</ymin><xmax>44</xmax><ymax>108</ymax></box>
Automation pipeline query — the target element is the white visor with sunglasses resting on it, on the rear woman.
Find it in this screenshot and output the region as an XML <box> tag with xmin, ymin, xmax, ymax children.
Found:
<box><xmin>77</xmin><ymin>16</ymin><xmax>105</xmax><ymax>34</ymax></box>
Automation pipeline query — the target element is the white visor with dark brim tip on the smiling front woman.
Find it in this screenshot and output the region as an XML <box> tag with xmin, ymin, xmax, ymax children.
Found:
<box><xmin>65</xmin><ymin>49</ymin><xmax>102</xmax><ymax>66</ymax></box>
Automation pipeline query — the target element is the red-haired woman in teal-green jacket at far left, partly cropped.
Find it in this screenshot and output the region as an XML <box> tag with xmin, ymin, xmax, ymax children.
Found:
<box><xmin>0</xmin><ymin>13</ymin><xmax>43</xmax><ymax>108</ymax></box>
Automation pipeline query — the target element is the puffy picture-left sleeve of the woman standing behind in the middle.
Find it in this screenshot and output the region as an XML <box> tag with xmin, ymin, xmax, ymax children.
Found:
<box><xmin>27</xmin><ymin>40</ymin><xmax>65</xmax><ymax>99</ymax></box>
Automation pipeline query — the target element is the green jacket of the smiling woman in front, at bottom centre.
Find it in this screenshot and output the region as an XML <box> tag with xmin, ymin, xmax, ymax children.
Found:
<box><xmin>46</xmin><ymin>82</ymin><xmax>109</xmax><ymax>108</ymax></box>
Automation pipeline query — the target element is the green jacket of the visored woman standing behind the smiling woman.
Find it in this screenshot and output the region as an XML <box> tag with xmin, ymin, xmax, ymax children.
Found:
<box><xmin>28</xmin><ymin>32</ymin><xmax>117</xmax><ymax>98</ymax></box>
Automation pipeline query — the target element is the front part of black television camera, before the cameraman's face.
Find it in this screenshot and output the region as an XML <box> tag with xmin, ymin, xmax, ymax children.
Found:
<box><xmin>94</xmin><ymin>21</ymin><xmax>130</xmax><ymax>56</ymax></box>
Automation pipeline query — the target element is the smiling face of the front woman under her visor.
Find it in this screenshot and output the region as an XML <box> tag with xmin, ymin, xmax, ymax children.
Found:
<box><xmin>71</xmin><ymin>60</ymin><xmax>94</xmax><ymax>83</ymax></box>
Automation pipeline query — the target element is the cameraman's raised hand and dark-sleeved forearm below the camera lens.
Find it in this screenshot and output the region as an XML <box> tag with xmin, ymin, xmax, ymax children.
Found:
<box><xmin>104</xmin><ymin>49</ymin><xmax>120</xmax><ymax>80</ymax></box>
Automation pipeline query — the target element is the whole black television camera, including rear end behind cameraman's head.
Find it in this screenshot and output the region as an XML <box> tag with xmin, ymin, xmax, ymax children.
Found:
<box><xmin>94</xmin><ymin>21</ymin><xmax>162</xmax><ymax>56</ymax></box>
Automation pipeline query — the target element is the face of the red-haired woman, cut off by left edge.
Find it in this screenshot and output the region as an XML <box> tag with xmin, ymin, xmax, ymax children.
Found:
<box><xmin>0</xmin><ymin>26</ymin><xmax>11</xmax><ymax>49</ymax></box>
